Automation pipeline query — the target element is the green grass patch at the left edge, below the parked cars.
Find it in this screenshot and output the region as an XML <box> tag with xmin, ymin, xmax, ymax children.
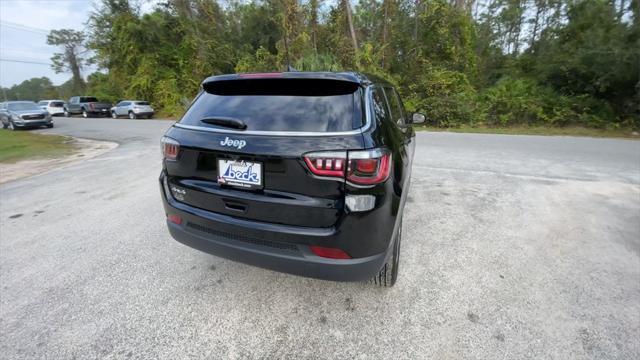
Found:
<box><xmin>0</xmin><ymin>130</ymin><xmax>75</xmax><ymax>163</ymax></box>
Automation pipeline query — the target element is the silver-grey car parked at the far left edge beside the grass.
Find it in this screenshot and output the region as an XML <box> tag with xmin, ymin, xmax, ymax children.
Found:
<box><xmin>0</xmin><ymin>101</ymin><xmax>53</xmax><ymax>130</ymax></box>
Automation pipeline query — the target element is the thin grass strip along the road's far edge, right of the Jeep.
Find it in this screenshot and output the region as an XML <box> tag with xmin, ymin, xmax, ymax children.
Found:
<box><xmin>414</xmin><ymin>125</ymin><xmax>640</xmax><ymax>139</ymax></box>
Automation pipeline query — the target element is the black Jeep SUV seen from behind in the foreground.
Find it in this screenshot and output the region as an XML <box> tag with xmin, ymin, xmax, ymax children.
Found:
<box><xmin>160</xmin><ymin>72</ymin><xmax>424</xmax><ymax>286</ymax></box>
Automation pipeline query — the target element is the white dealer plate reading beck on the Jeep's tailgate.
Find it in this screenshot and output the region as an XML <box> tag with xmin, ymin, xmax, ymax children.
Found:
<box><xmin>218</xmin><ymin>159</ymin><xmax>263</xmax><ymax>189</ymax></box>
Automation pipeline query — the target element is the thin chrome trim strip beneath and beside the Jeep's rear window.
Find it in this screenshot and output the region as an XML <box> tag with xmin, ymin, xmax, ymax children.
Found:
<box><xmin>173</xmin><ymin>87</ymin><xmax>373</xmax><ymax>136</ymax></box>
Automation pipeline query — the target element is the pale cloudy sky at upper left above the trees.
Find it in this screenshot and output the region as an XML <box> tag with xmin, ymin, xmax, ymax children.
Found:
<box><xmin>0</xmin><ymin>0</ymin><xmax>156</xmax><ymax>87</ymax></box>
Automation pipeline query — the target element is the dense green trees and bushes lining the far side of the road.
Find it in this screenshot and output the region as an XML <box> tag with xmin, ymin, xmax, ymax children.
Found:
<box><xmin>6</xmin><ymin>0</ymin><xmax>640</xmax><ymax>133</ymax></box>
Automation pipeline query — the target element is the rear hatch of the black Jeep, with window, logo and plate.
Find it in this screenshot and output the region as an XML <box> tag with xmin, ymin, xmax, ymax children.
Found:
<box><xmin>165</xmin><ymin>76</ymin><xmax>365</xmax><ymax>227</ymax></box>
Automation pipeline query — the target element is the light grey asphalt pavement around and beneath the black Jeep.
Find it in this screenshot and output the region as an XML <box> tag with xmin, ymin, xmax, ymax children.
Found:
<box><xmin>0</xmin><ymin>119</ymin><xmax>640</xmax><ymax>359</ymax></box>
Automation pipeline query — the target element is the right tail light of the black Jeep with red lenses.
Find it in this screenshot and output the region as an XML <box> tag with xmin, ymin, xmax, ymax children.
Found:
<box><xmin>304</xmin><ymin>149</ymin><xmax>391</xmax><ymax>185</ymax></box>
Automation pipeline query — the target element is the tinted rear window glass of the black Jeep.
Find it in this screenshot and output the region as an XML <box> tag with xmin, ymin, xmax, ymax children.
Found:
<box><xmin>180</xmin><ymin>79</ymin><xmax>363</xmax><ymax>132</ymax></box>
